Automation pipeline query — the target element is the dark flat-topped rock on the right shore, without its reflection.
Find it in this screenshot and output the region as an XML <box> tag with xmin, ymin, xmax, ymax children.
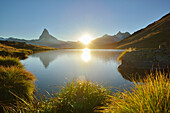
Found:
<box><xmin>121</xmin><ymin>49</ymin><xmax>170</xmax><ymax>69</ymax></box>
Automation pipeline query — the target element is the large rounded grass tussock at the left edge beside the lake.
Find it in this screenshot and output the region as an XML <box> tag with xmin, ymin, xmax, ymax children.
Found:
<box><xmin>0</xmin><ymin>66</ymin><xmax>35</xmax><ymax>103</ymax></box>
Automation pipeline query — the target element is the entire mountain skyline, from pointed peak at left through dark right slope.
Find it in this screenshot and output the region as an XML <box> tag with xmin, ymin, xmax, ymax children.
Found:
<box><xmin>0</xmin><ymin>13</ymin><xmax>170</xmax><ymax>49</ymax></box>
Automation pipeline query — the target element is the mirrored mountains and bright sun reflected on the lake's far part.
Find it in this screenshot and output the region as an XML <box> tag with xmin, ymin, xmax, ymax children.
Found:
<box><xmin>30</xmin><ymin>48</ymin><xmax>122</xmax><ymax>68</ymax></box>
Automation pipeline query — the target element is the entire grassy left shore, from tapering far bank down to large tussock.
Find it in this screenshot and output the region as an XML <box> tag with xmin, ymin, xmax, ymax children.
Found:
<box><xmin>0</xmin><ymin>41</ymin><xmax>56</xmax><ymax>112</ymax></box>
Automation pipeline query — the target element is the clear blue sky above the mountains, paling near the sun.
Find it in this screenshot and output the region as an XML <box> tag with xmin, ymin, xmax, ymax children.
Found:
<box><xmin>0</xmin><ymin>0</ymin><xmax>170</xmax><ymax>41</ymax></box>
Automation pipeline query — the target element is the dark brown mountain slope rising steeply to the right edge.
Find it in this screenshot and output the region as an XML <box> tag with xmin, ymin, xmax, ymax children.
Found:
<box><xmin>115</xmin><ymin>13</ymin><xmax>170</xmax><ymax>48</ymax></box>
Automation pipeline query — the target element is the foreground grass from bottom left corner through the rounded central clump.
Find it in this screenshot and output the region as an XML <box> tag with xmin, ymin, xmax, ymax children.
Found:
<box><xmin>3</xmin><ymin>80</ymin><xmax>110</xmax><ymax>113</ymax></box>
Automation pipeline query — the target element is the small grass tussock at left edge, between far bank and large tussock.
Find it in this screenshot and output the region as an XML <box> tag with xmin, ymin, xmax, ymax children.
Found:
<box><xmin>0</xmin><ymin>56</ymin><xmax>23</xmax><ymax>68</ymax></box>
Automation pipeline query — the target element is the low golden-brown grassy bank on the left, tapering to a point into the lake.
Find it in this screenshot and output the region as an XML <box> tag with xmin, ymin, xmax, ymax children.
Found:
<box><xmin>0</xmin><ymin>41</ymin><xmax>57</xmax><ymax>59</ymax></box>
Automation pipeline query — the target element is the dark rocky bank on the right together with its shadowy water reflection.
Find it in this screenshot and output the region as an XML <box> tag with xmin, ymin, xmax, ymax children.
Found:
<box><xmin>118</xmin><ymin>48</ymin><xmax>170</xmax><ymax>81</ymax></box>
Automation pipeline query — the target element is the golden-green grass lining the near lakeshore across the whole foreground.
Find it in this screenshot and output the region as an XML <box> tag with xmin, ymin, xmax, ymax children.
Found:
<box><xmin>0</xmin><ymin>40</ymin><xmax>170</xmax><ymax>113</ymax></box>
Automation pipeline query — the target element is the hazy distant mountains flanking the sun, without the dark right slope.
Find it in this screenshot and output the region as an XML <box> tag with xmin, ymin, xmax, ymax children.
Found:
<box><xmin>0</xmin><ymin>29</ymin><xmax>130</xmax><ymax>48</ymax></box>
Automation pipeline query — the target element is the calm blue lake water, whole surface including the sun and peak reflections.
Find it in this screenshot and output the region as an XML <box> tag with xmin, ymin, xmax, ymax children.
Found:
<box><xmin>21</xmin><ymin>48</ymin><xmax>132</xmax><ymax>92</ymax></box>
